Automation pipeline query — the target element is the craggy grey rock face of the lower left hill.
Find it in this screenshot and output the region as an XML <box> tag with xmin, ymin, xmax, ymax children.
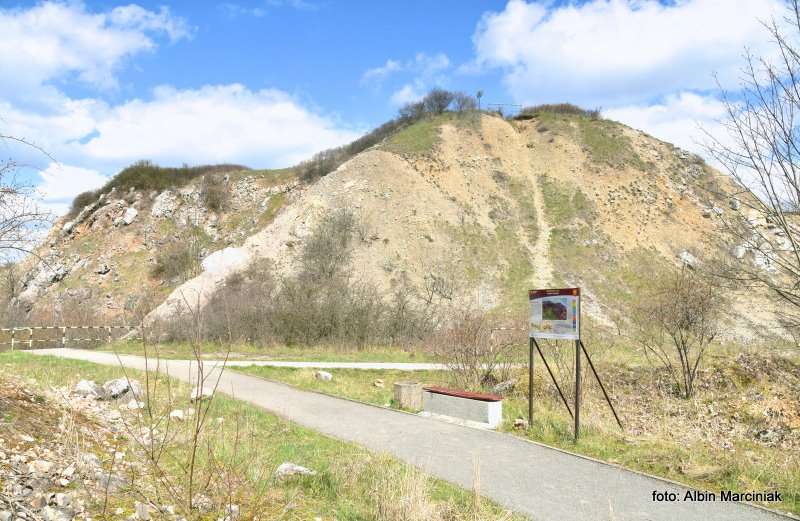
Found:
<box><xmin>18</xmin><ymin>167</ymin><xmax>297</xmax><ymax>323</ymax></box>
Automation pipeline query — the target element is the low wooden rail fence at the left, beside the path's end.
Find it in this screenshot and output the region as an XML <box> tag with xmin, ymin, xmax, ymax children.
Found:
<box><xmin>0</xmin><ymin>326</ymin><xmax>136</xmax><ymax>351</ymax></box>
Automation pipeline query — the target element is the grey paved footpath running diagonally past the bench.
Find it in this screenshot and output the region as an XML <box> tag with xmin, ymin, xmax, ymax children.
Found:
<box><xmin>32</xmin><ymin>349</ymin><xmax>787</xmax><ymax>521</ymax></box>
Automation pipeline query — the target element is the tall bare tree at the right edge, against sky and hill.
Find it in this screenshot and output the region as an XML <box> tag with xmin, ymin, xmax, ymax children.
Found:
<box><xmin>707</xmin><ymin>0</ymin><xmax>800</xmax><ymax>329</ymax></box>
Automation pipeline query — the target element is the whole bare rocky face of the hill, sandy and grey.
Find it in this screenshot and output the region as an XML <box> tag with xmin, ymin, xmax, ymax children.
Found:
<box><xmin>17</xmin><ymin>114</ymin><xmax>771</xmax><ymax>342</ymax></box>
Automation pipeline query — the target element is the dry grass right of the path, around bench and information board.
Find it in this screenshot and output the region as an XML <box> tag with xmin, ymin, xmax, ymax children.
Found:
<box><xmin>242</xmin><ymin>345</ymin><xmax>800</xmax><ymax>514</ymax></box>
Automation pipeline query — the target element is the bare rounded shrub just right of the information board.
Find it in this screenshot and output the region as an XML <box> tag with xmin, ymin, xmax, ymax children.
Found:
<box><xmin>632</xmin><ymin>266</ymin><xmax>725</xmax><ymax>398</ymax></box>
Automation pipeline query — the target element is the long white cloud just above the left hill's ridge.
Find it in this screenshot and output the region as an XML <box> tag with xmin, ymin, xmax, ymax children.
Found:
<box><xmin>73</xmin><ymin>84</ymin><xmax>359</xmax><ymax>167</ymax></box>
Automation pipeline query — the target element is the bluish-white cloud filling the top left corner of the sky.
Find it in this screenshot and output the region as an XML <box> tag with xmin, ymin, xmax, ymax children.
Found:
<box><xmin>0</xmin><ymin>2</ymin><xmax>191</xmax><ymax>96</ymax></box>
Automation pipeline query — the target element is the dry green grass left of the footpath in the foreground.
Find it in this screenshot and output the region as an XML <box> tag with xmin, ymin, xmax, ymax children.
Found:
<box><xmin>0</xmin><ymin>353</ymin><xmax>521</xmax><ymax>521</ymax></box>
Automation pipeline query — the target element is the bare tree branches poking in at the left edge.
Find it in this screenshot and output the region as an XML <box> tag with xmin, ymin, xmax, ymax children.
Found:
<box><xmin>0</xmin><ymin>134</ymin><xmax>50</xmax><ymax>257</ymax></box>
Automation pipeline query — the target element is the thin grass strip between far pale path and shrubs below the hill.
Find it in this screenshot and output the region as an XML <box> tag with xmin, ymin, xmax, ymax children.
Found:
<box><xmin>100</xmin><ymin>342</ymin><xmax>434</xmax><ymax>363</ymax></box>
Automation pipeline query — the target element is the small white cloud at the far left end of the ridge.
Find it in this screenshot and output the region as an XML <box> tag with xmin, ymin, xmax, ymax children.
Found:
<box><xmin>37</xmin><ymin>163</ymin><xmax>108</xmax><ymax>215</ymax></box>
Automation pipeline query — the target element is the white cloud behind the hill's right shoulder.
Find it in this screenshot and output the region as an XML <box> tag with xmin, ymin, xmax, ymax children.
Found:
<box><xmin>603</xmin><ymin>92</ymin><xmax>726</xmax><ymax>156</ymax></box>
